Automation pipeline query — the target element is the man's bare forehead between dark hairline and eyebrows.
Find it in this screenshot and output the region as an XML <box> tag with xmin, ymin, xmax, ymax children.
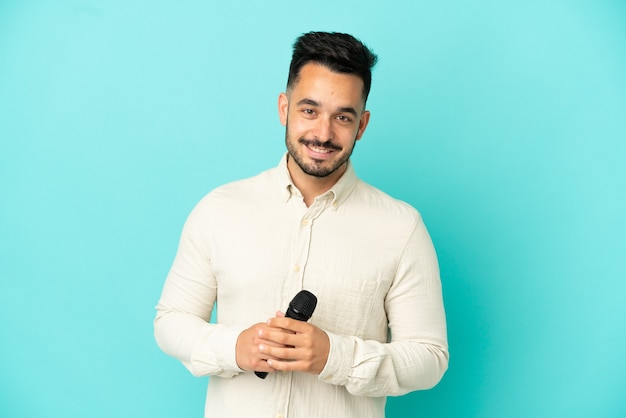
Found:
<box><xmin>290</xmin><ymin>63</ymin><xmax>364</xmax><ymax>109</ymax></box>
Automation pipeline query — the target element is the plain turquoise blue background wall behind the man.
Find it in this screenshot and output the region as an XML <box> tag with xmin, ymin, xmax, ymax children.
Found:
<box><xmin>0</xmin><ymin>0</ymin><xmax>626</xmax><ymax>418</ymax></box>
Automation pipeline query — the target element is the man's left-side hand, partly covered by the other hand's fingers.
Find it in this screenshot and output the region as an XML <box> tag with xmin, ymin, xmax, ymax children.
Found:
<box><xmin>235</xmin><ymin>322</ymin><xmax>284</xmax><ymax>372</ymax></box>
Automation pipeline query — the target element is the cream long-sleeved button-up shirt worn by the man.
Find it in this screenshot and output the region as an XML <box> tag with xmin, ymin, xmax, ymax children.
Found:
<box><xmin>155</xmin><ymin>156</ymin><xmax>448</xmax><ymax>418</ymax></box>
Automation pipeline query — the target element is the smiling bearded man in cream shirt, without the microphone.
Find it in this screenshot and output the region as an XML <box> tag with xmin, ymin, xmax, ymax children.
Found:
<box><xmin>155</xmin><ymin>32</ymin><xmax>448</xmax><ymax>418</ymax></box>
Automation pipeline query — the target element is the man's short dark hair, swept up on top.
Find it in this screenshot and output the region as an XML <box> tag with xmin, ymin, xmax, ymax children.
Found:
<box><xmin>287</xmin><ymin>32</ymin><xmax>378</xmax><ymax>102</ymax></box>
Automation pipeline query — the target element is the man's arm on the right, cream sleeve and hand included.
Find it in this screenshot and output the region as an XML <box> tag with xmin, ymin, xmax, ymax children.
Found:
<box><xmin>264</xmin><ymin>219</ymin><xmax>448</xmax><ymax>396</ymax></box>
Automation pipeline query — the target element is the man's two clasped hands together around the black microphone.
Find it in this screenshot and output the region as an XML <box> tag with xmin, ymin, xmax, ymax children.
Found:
<box><xmin>235</xmin><ymin>312</ymin><xmax>330</xmax><ymax>374</ymax></box>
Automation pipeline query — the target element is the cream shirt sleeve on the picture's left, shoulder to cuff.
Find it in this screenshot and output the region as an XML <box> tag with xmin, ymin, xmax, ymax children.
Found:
<box><xmin>154</xmin><ymin>202</ymin><xmax>244</xmax><ymax>378</ymax></box>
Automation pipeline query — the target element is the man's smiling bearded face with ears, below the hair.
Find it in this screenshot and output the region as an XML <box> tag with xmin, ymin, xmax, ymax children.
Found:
<box><xmin>278</xmin><ymin>63</ymin><xmax>370</xmax><ymax>182</ymax></box>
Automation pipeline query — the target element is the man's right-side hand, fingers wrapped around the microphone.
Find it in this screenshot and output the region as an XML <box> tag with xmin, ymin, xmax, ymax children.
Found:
<box><xmin>260</xmin><ymin>312</ymin><xmax>330</xmax><ymax>374</ymax></box>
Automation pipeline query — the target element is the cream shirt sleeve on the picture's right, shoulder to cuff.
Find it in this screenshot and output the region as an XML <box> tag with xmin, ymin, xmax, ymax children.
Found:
<box><xmin>319</xmin><ymin>217</ymin><xmax>449</xmax><ymax>396</ymax></box>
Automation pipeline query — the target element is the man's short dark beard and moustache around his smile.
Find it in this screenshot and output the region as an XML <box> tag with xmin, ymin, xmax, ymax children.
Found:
<box><xmin>285</xmin><ymin>124</ymin><xmax>356</xmax><ymax>177</ymax></box>
